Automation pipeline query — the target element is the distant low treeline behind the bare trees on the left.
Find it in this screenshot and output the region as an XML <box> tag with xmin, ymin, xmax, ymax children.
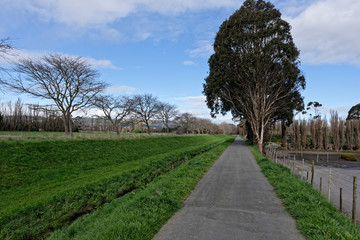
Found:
<box><xmin>0</xmin><ymin>99</ymin><xmax>237</xmax><ymax>134</ymax></box>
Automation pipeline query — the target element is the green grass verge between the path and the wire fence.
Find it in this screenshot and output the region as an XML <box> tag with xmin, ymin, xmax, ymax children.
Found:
<box><xmin>249</xmin><ymin>142</ymin><xmax>360</xmax><ymax>239</ymax></box>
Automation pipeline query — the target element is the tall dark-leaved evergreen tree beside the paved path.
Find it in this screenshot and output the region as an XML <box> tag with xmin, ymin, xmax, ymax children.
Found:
<box><xmin>204</xmin><ymin>0</ymin><xmax>305</xmax><ymax>151</ymax></box>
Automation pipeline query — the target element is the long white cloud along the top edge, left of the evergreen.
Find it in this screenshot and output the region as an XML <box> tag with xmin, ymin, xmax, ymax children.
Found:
<box><xmin>5</xmin><ymin>0</ymin><xmax>243</xmax><ymax>27</ymax></box>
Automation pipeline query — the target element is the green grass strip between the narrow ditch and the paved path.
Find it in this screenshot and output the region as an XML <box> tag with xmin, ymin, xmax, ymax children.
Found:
<box><xmin>50</xmin><ymin>137</ymin><xmax>234</xmax><ymax>240</ymax></box>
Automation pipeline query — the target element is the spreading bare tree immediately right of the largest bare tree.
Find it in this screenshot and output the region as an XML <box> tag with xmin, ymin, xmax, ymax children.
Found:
<box><xmin>93</xmin><ymin>95</ymin><xmax>133</xmax><ymax>136</ymax></box>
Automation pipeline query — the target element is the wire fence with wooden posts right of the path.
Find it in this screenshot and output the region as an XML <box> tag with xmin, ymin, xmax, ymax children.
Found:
<box><xmin>265</xmin><ymin>147</ymin><xmax>360</xmax><ymax>223</ymax></box>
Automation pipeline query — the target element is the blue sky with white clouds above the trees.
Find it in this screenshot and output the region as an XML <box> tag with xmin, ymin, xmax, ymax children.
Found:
<box><xmin>0</xmin><ymin>0</ymin><xmax>360</xmax><ymax>123</ymax></box>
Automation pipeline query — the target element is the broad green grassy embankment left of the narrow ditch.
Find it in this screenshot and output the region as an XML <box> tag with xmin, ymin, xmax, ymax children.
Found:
<box><xmin>0</xmin><ymin>136</ymin><xmax>235</xmax><ymax>239</ymax></box>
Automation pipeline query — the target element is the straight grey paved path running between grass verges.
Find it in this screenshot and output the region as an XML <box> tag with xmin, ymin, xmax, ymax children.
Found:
<box><xmin>154</xmin><ymin>138</ymin><xmax>305</xmax><ymax>240</ymax></box>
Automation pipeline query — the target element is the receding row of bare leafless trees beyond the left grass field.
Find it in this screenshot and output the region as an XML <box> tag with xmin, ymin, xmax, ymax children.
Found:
<box><xmin>0</xmin><ymin>39</ymin><xmax>236</xmax><ymax>136</ymax></box>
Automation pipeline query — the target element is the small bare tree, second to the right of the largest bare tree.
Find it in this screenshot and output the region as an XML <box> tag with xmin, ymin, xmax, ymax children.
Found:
<box><xmin>132</xmin><ymin>94</ymin><xmax>159</xmax><ymax>135</ymax></box>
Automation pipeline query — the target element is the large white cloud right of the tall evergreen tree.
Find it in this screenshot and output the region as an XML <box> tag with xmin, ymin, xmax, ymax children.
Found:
<box><xmin>287</xmin><ymin>0</ymin><xmax>360</xmax><ymax>66</ymax></box>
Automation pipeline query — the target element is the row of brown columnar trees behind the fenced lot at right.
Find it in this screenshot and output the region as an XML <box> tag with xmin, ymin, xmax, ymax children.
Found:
<box><xmin>273</xmin><ymin>112</ymin><xmax>360</xmax><ymax>151</ymax></box>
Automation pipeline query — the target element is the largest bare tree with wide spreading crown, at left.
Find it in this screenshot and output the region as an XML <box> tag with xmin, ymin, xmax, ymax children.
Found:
<box><xmin>2</xmin><ymin>54</ymin><xmax>107</xmax><ymax>137</ymax></box>
